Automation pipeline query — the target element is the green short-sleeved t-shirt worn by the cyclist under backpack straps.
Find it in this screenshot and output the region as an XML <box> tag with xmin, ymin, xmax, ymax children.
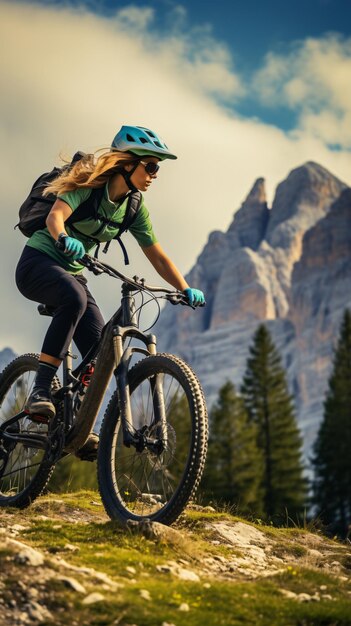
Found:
<box><xmin>27</xmin><ymin>184</ymin><xmax>157</xmax><ymax>274</ymax></box>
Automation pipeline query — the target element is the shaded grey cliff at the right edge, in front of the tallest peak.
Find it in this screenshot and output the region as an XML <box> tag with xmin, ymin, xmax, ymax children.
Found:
<box><xmin>288</xmin><ymin>189</ymin><xmax>351</xmax><ymax>449</ymax></box>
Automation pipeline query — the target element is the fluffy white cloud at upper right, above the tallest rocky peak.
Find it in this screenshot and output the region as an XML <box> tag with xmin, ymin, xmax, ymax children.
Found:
<box><xmin>254</xmin><ymin>34</ymin><xmax>351</xmax><ymax>149</ymax></box>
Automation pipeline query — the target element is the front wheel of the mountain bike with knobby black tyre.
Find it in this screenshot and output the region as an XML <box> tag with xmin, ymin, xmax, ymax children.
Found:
<box><xmin>98</xmin><ymin>354</ymin><xmax>208</xmax><ymax>524</ymax></box>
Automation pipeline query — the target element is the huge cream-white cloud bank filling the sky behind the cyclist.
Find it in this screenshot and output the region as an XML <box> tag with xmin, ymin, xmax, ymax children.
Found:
<box><xmin>0</xmin><ymin>0</ymin><xmax>351</xmax><ymax>351</ymax></box>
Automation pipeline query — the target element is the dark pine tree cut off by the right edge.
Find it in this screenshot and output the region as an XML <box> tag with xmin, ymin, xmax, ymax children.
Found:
<box><xmin>313</xmin><ymin>311</ymin><xmax>351</xmax><ymax>536</ymax></box>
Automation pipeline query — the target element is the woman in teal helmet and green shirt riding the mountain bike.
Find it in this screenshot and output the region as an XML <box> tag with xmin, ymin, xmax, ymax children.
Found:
<box><xmin>16</xmin><ymin>126</ymin><xmax>204</xmax><ymax>418</ymax></box>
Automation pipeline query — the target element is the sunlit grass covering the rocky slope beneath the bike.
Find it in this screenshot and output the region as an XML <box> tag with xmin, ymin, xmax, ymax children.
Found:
<box><xmin>0</xmin><ymin>491</ymin><xmax>351</xmax><ymax>626</ymax></box>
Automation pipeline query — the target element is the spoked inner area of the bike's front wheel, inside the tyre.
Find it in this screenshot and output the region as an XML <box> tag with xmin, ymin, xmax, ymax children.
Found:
<box><xmin>115</xmin><ymin>373</ymin><xmax>192</xmax><ymax>515</ymax></box>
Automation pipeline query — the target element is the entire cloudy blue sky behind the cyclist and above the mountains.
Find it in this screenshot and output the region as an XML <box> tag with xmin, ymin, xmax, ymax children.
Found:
<box><xmin>0</xmin><ymin>0</ymin><xmax>351</xmax><ymax>352</ymax></box>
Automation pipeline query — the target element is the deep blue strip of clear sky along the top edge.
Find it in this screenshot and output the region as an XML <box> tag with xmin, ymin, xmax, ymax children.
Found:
<box><xmin>18</xmin><ymin>0</ymin><xmax>351</xmax><ymax>56</ymax></box>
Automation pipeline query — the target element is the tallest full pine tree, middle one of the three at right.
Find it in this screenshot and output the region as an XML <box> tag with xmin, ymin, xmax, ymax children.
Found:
<box><xmin>241</xmin><ymin>325</ymin><xmax>307</xmax><ymax>518</ymax></box>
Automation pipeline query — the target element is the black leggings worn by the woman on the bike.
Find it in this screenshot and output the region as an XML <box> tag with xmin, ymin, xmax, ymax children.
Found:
<box><xmin>16</xmin><ymin>246</ymin><xmax>104</xmax><ymax>359</ymax></box>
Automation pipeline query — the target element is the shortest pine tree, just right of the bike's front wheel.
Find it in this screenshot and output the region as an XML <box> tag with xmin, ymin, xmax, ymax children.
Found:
<box><xmin>202</xmin><ymin>382</ymin><xmax>262</xmax><ymax>515</ymax></box>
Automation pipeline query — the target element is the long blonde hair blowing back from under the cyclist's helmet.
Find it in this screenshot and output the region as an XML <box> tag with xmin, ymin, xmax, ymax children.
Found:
<box><xmin>44</xmin><ymin>150</ymin><xmax>139</xmax><ymax>196</ymax></box>
